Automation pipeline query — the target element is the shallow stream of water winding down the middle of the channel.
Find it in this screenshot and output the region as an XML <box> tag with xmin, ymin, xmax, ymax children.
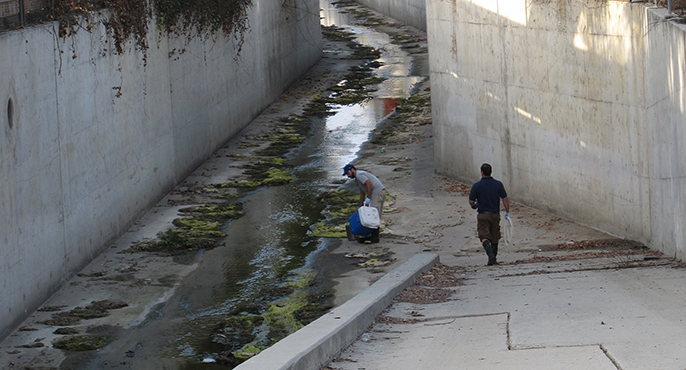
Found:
<box><xmin>62</xmin><ymin>0</ymin><xmax>425</xmax><ymax>369</ymax></box>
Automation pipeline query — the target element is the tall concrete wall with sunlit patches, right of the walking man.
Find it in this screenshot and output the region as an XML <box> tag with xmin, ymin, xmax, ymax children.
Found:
<box><xmin>427</xmin><ymin>0</ymin><xmax>686</xmax><ymax>259</ymax></box>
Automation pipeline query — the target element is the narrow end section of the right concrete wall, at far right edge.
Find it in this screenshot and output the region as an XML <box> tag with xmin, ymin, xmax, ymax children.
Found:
<box><xmin>645</xmin><ymin>9</ymin><xmax>686</xmax><ymax>259</ymax></box>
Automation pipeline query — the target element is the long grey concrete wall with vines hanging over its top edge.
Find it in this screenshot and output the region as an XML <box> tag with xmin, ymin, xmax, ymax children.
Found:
<box><xmin>0</xmin><ymin>0</ymin><xmax>322</xmax><ymax>338</ymax></box>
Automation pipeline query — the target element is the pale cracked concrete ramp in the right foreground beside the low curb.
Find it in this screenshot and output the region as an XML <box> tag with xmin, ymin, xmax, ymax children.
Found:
<box><xmin>326</xmin><ymin>256</ymin><xmax>686</xmax><ymax>370</ymax></box>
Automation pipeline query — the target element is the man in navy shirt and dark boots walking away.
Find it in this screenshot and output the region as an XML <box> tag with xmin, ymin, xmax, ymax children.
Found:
<box><xmin>469</xmin><ymin>163</ymin><xmax>510</xmax><ymax>266</ymax></box>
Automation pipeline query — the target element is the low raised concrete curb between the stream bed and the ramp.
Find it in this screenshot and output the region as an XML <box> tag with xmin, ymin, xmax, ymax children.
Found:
<box><xmin>235</xmin><ymin>254</ymin><xmax>438</xmax><ymax>370</ymax></box>
